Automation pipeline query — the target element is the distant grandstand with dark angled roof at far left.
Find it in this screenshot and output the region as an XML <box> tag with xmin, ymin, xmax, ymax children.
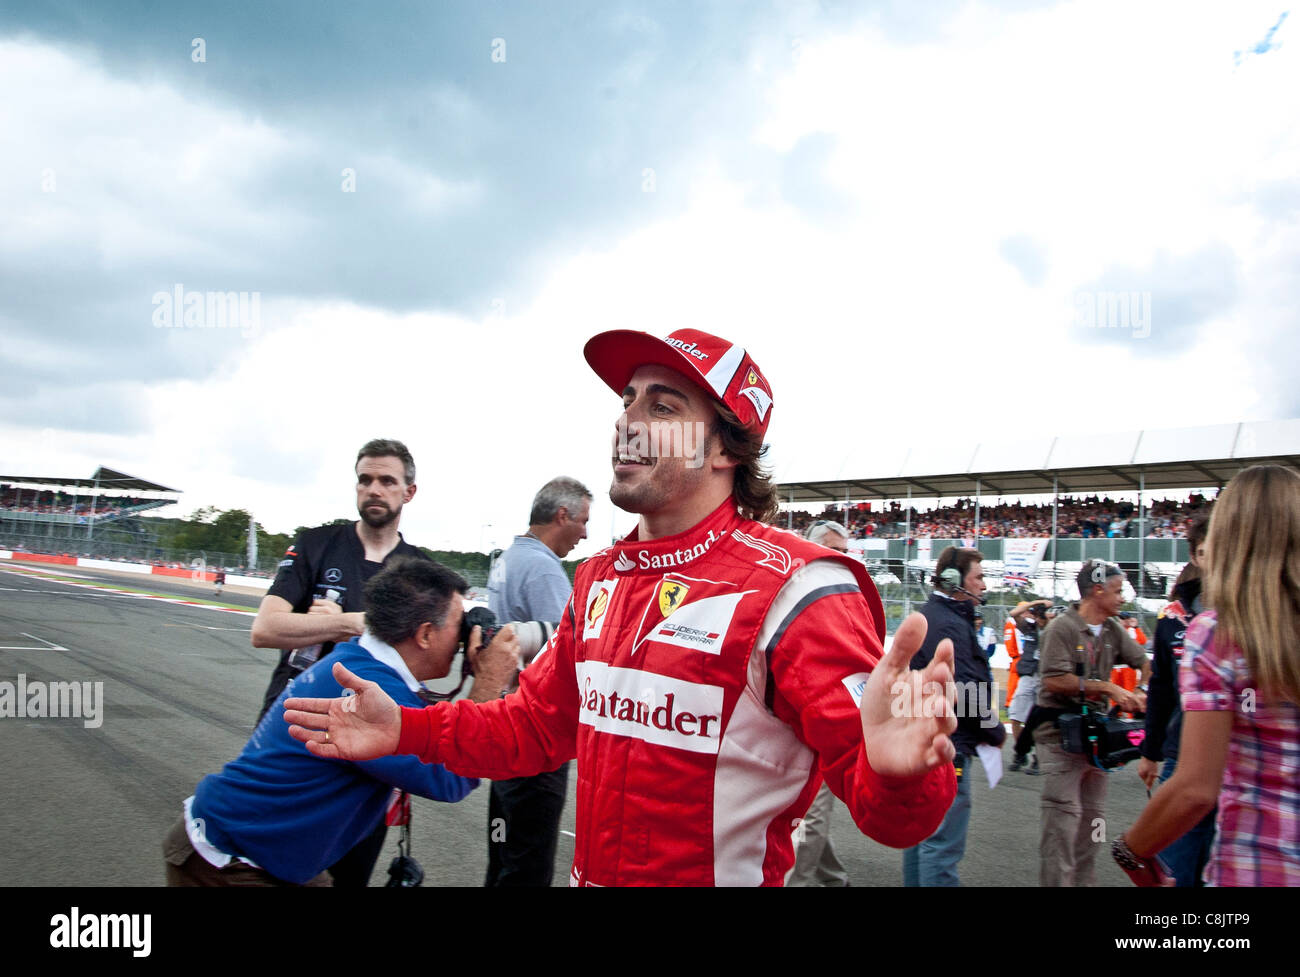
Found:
<box><xmin>0</xmin><ymin>465</ymin><xmax>181</xmax><ymax>556</ymax></box>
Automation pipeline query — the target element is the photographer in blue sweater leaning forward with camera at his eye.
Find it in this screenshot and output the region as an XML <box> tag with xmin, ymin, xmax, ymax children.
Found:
<box><xmin>163</xmin><ymin>557</ymin><xmax>519</xmax><ymax>886</ymax></box>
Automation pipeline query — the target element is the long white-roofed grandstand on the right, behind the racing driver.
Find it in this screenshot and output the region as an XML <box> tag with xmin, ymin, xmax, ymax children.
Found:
<box><xmin>777</xmin><ymin>418</ymin><xmax>1300</xmax><ymax>618</ymax></box>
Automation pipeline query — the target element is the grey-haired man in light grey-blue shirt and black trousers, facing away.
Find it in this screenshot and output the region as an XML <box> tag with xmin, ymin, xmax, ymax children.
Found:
<box><xmin>484</xmin><ymin>477</ymin><xmax>592</xmax><ymax>886</ymax></box>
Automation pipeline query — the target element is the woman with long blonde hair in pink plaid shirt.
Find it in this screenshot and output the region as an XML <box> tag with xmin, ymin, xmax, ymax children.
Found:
<box><xmin>1113</xmin><ymin>465</ymin><xmax>1300</xmax><ymax>886</ymax></box>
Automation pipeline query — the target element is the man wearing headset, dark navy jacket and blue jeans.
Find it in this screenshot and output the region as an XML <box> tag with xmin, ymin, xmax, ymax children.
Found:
<box><xmin>902</xmin><ymin>546</ymin><xmax>1006</xmax><ymax>886</ymax></box>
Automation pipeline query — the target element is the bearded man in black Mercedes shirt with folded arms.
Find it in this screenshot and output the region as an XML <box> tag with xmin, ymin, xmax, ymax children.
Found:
<box><xmin>252</xmin><ymin>439</ymin><xmax>428</xmax><ymax>886</ymax></box>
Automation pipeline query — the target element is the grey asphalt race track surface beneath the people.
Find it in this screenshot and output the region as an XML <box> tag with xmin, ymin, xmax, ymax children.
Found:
<box><xmin>0</xmin><ymin>563</ymin><xmax>1147</xmax><ymax>886</ymax></box>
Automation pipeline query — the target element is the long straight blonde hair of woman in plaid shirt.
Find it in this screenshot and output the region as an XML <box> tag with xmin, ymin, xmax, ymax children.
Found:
<box><xmin>1205</xmin><ymin>465</ymin><xmax>1300</xmax><ymax>703</ymax></box>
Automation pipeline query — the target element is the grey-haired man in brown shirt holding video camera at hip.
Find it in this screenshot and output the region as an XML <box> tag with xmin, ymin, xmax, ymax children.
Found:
<box><xmin>1034</xmin><ymin>560</ymin><xmax>1151</xmax><ymax>886</ymax></box>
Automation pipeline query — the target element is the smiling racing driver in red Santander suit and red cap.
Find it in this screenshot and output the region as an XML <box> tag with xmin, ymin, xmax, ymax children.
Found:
<box><xmin>286</xmin><ymin>330</ymin><xmax>956</xmax><ymax>885</ymax></box>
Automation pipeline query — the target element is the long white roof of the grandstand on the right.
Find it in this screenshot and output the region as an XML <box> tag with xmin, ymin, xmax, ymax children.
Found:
<box><xmin>779</xmin><ymin>418</ymin><xmax>1300</xmax><ymax>503</ymax></box>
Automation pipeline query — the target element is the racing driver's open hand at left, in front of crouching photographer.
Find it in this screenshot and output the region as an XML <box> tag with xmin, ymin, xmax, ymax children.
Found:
<box><xmin>285</xmin><ymin>661</ymin><xmax>402</xmax><ymax>760</ymax></box>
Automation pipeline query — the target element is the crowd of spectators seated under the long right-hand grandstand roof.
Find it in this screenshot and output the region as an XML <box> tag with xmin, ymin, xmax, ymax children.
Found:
<box><xmin>777</xmin><ymin>494</ymin><xmax>1213</xmax><ymax>539</ymax></box>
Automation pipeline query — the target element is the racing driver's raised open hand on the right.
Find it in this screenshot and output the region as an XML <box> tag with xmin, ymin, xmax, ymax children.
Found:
<box><xmin>862</xmin><ymin>613</ymin><xmax>957</xmax><ymax>777</ymax></box>
